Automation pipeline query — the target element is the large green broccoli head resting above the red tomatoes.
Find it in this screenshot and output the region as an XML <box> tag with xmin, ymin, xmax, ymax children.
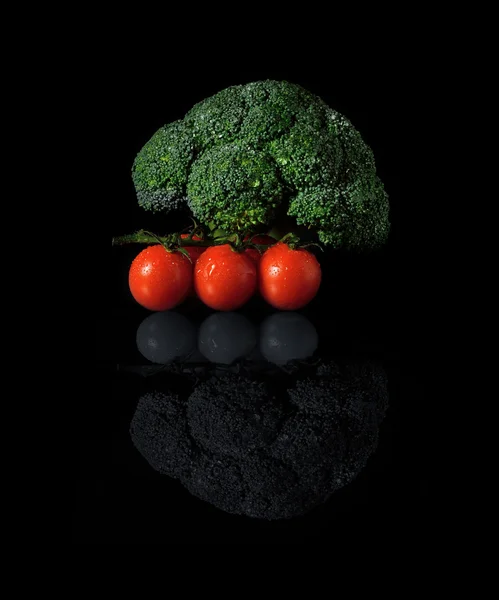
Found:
<box><xmin>132</xmin><ymin>80</ymin><xmax>390</xmax><ymax>249</ymax></box>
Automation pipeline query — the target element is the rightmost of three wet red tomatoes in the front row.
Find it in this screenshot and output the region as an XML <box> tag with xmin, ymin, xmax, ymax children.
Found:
<box><xmin>258</xmin><ymin>242</ymin><xmax>322</xmax><ymax>310</ymax></box>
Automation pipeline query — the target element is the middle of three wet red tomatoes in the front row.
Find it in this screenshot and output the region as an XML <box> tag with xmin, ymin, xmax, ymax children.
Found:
<box><xmin>194</xmin><ymin>244</ymin><xmax>257</xmax><ymax>310</ymax></box>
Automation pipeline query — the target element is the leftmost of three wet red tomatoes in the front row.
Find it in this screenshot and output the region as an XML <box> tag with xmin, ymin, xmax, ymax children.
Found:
<box><xmin>128</xmin><ymin>244</ymin><xmax>193</xmax><ymax>311</ymax></box>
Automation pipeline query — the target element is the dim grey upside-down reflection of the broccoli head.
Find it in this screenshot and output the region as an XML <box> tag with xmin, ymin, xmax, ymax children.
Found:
<box><xmin>131</xmin><ymin>363</ymin><xmax>387</xmax><ymax>519</ymax></box>
